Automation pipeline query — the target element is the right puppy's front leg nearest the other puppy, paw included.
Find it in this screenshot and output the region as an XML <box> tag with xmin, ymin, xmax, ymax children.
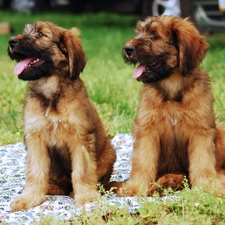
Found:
<box><xmin>117</xmin><ymin>133</ymin><xmax>160</xmax><ymax>196</ymax></box>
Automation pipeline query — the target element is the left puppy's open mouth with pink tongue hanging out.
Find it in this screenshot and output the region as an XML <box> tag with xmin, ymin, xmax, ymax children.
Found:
<box><xmin>14</xmin><ymin>58</ymin><xmax>45</xmax><ymax>75</ymax></box>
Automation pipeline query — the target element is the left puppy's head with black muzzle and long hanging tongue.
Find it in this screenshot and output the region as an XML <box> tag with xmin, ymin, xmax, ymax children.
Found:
<box><xmin>8</xmin><ymin>21</ymin><xmax>86</xmax><ymax>80</ymax></box>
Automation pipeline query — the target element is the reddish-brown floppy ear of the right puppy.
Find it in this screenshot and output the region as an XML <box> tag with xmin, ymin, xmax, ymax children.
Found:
<box><xmin>172</xmin><ymin>18</ymin><xmax>209</xmax><ymax>76</ymax></box>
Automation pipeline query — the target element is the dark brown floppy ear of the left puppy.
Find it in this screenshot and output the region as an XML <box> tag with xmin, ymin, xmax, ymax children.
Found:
<box><xmin>61</xmin><ymin>28</ymin><xmax>86</xmax><ymax>79</ymax></box>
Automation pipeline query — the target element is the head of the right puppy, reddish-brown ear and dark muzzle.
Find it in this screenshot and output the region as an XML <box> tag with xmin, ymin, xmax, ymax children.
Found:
<box><xmin>123</xmin><ymin>16</ymin><xmax>208</xmax><ymax>83</ymax></box>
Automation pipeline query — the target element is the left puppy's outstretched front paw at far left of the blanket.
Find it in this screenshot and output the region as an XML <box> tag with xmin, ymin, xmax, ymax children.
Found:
<box><xmin>10</xmin><ymin>196</ymin><xmax>45</xmax><ymax>212</ymax></box>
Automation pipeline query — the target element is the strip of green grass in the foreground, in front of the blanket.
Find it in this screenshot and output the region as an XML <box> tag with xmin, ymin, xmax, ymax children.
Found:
<box><xmin>38</xmin><ymin>183</ymin><xmax>225</xmax><ymax>225</ymax></box>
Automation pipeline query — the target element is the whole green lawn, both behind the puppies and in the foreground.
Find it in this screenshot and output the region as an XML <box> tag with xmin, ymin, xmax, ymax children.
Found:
<box><xmin>0</xmin><ymin>12</ymin><xmax>225</xmax><ymax>224</ymax></box>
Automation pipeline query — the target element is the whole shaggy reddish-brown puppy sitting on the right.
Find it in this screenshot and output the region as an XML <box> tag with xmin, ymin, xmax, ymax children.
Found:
<box><xmin>114</xmin><ymin>16</ymin><xmax>225</xmax><ymax>195</ymax></box>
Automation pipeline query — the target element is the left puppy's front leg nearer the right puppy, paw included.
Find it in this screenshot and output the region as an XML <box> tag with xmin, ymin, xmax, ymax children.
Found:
<box><xmin>70</xmin><ymin>144</ymin><xmax>100</xmax><ymax>205</ymax></box>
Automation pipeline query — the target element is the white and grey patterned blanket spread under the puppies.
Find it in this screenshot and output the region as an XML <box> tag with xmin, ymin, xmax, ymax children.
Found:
<box><xmin>0</xmin><ymin>134</ymin><xmax>174</xmax><ymax>225</ymax></box>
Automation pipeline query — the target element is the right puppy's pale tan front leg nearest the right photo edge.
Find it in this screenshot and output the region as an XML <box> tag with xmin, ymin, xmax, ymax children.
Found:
<box><xmin>188</xmin><ymin>131</ymin><xmax>225</xmax><ymax>194</ymax></box>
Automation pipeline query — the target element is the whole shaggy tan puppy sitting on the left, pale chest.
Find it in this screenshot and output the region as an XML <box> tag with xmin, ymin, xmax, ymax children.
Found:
<box><xmin>8</xmin><ymin>21</ymin><xmax>116</xmax><ymax>211</ymax></box>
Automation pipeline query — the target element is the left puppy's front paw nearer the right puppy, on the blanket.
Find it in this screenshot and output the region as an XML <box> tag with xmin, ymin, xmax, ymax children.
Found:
<box><xmin>74</xmin><ymin>191</ymin><xmax>100</xmax><ymax>206</ymax></box>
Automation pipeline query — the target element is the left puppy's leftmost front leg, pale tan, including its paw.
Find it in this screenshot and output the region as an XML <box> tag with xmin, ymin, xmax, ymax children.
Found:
<box><xmin>11</xmin><ymin>135</ymin><xmax>50</xmax><ymax>211</ymax></box>
